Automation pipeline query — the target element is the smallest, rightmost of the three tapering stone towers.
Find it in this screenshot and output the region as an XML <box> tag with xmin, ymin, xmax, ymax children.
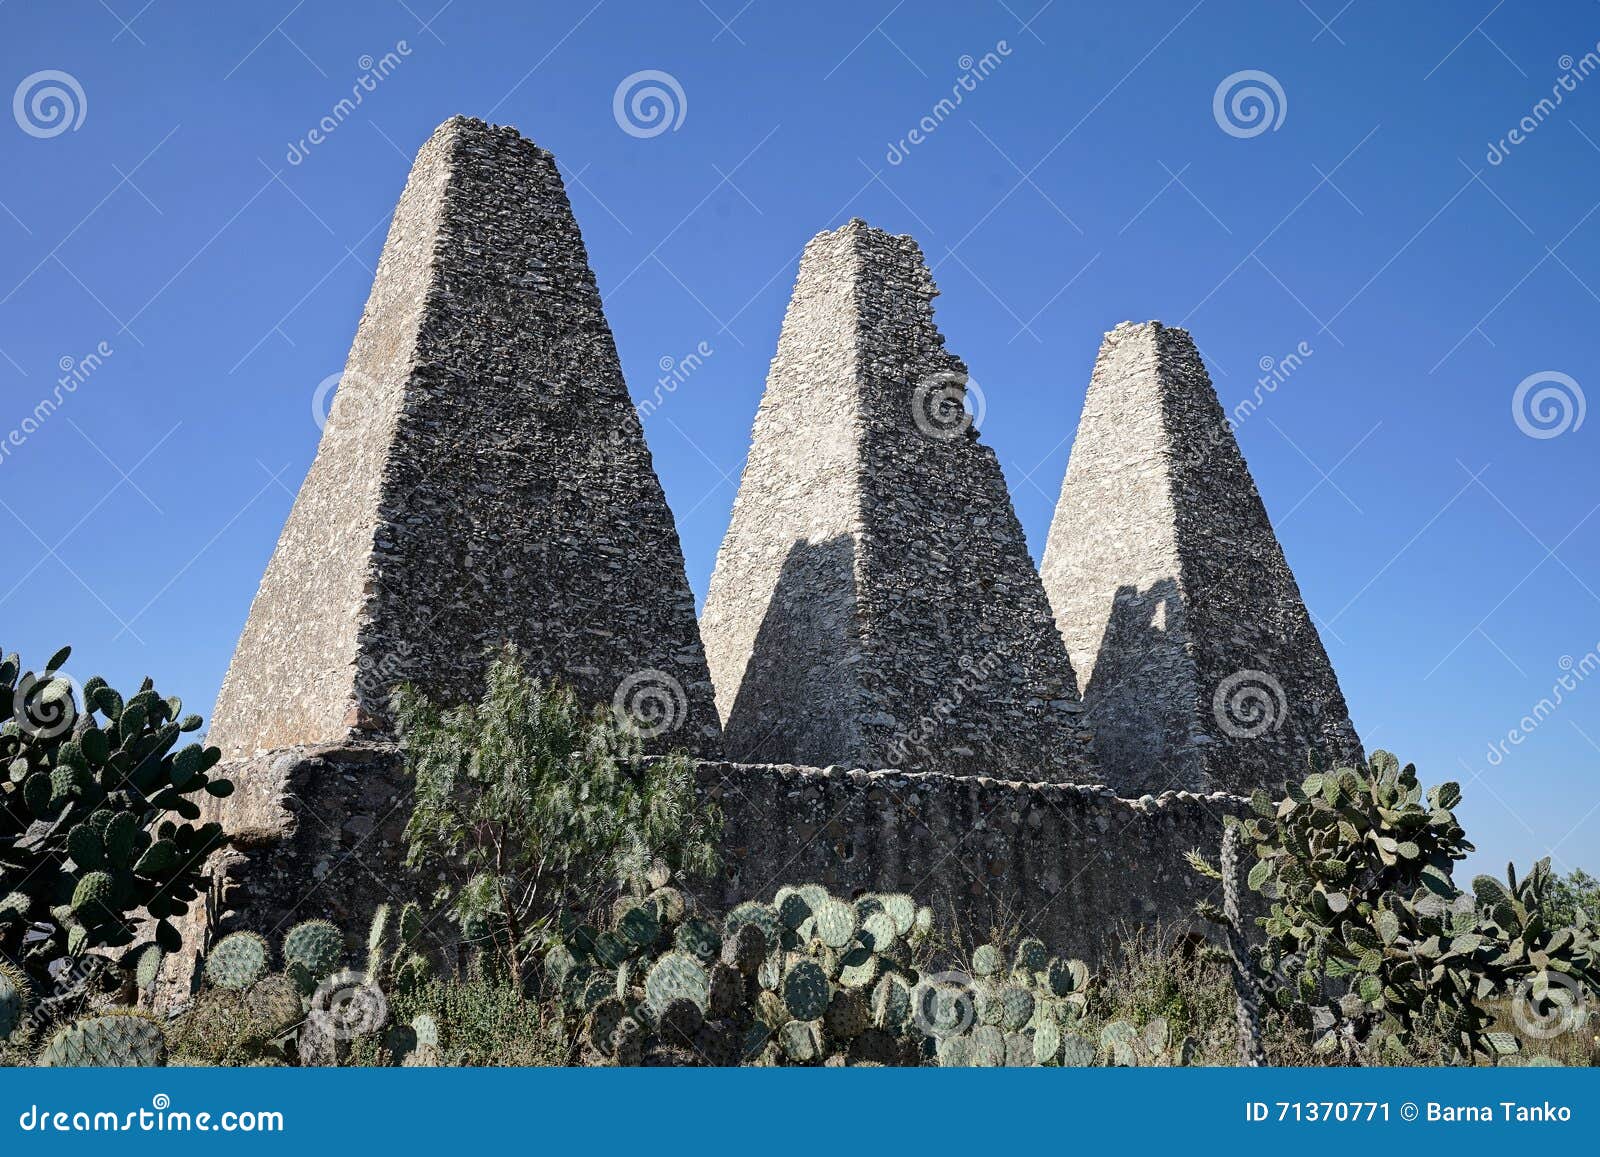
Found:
<box><xmin>1042</xmin><ymin>322</ymin><xmax>1362</xmax><ymax>794</ymax></box>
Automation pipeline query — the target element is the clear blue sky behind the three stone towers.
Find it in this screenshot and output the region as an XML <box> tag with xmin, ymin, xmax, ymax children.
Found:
<box><xmin>0</xmin><ymin>0</ymin><xmax>1600</xmax><ymax>871</ymax></box>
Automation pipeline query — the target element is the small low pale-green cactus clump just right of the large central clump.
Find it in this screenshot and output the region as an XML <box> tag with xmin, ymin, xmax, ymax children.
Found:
<box><xmin>912</xmin><ymin>936</ymin><xmax>1094</xmax><ymax>1067</ymax></box>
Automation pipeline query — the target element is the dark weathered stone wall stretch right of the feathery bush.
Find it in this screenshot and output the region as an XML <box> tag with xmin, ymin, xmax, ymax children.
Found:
<box><xmin>699</xmin><ymin>763</ymin><xmax>1248</xmax><ymax>963</ymax></box>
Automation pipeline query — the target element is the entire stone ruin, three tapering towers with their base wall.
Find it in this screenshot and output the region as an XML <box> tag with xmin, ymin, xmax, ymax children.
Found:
<box><xmin>166</xmin><ymin>118</ymin><xmax>1358</xmax><ymax>994</ymax></box>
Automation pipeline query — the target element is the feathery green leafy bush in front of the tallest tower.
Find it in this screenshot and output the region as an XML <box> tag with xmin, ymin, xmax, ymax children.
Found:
<box><xmin>394</xmin><ymin>648</ymin><xmax>722</xmax><ymax>987</ymax></box>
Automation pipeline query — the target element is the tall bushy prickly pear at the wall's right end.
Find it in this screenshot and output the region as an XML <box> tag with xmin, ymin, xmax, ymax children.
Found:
<box><xmin>1192</xmin><ymin>751</ymin><xmax>1600</xmax><ymax>1063</ymax></box>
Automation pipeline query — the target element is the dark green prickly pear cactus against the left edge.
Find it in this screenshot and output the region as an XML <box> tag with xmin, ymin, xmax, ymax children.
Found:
<box><xmin>0</xmin><ymin>648</ymin><xmax>232</xmax><ymax>987</ymax></box>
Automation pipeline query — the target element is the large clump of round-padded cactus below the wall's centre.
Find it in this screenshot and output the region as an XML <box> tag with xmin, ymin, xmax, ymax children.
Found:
<box><xmin>544</xmin><ymin>879</ymin><xmax>933</xmax><ymax>1066</ymax></box>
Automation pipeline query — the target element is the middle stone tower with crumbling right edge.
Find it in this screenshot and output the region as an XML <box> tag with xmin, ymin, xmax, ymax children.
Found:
<box><xmin>701</xmin><ymin>221</ymin><xmax>1091</xmax><ymax>781</ymax></box>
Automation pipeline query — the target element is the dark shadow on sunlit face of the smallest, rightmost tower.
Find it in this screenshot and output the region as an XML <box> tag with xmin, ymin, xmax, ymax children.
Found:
<box><xmin>1083</xmin><ymin>579</ymin><xmax>1208</xmax><ymax>795</ymax></box>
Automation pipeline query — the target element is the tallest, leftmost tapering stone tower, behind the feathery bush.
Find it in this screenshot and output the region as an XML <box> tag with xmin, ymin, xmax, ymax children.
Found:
<box><xmin>210</xmin><ymin>117</ymin><xmax>718</xmax><ymax>761</ymax></box>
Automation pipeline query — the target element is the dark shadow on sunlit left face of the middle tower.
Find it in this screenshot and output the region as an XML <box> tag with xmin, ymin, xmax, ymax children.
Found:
<box><xmin>725</xmin><ymin>534</ymin><xmax>861</xmax><ymax>767</ymax></box>
